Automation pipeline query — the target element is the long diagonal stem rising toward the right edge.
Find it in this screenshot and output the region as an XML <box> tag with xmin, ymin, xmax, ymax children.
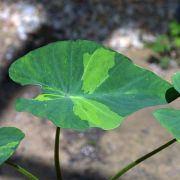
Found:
<box><xmin>110</xmin><ymin>139</ymin><xmax>176</xmax><ymax>180</ymax></box>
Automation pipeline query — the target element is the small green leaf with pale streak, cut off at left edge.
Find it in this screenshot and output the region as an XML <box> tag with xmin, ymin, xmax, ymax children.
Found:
<box><xmin>0</xmin><ymin>127</ymin><xmax>24</xmax><ymax>165</ymax></box>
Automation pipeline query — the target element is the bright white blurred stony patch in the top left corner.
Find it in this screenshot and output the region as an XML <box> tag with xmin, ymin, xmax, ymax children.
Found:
<box><xmin>0</xmin><ymin>2</ymin><xmax>45</xmax><ymax>40</ymax></box>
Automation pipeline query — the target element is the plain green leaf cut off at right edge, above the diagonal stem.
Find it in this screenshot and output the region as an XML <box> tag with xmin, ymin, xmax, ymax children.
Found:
<box><xmin>153</xmin><ymin>108</ymin><xmax>180</xmax><ymax>142</ymax></box>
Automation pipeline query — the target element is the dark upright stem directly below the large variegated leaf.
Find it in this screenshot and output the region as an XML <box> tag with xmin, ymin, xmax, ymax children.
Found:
<box><xmin>54</xmin><ymin>127</ymin><xmax>63</xmax><ymax>180</ymax></box>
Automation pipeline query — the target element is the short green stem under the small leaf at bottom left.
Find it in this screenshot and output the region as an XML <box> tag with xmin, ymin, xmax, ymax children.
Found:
<box><xmin>5</xmin><ymin>160</ymin><xmax>38</xmax><ymax>180</ymax></box>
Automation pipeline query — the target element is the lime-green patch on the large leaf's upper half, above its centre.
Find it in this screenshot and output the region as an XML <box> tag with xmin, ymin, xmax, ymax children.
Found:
<box><xmin>82</xmin><ymin>48</ymin><xmax>115</xmax><ymax>94</ymax></box>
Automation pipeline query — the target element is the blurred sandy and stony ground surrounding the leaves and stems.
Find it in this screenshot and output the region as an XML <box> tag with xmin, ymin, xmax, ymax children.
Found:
<box><xmin>0</xmin><ymin>0</ymin><xmax>180</xmax><ymax>180</ymax></box>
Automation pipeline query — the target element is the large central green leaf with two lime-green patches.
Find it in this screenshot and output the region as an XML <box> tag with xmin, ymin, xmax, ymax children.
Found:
<box><xmin>9</xmin><ymin>40</ymin><xmax>179</xmax><ymax>130</ymax></box>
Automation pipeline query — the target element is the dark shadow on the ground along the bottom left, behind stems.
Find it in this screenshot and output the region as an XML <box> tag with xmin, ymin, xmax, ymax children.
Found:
<box><xmin>0</xmin><ymin>156</ymin><xmax>107</xmax><ymax>180</ymax></box>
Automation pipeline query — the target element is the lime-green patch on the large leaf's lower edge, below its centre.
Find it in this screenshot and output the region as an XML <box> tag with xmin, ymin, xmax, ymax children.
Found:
<box><xmin>71</xmin><ymin>97</ymin><xmax>123</xmax><ymax>130</ymax></box>
